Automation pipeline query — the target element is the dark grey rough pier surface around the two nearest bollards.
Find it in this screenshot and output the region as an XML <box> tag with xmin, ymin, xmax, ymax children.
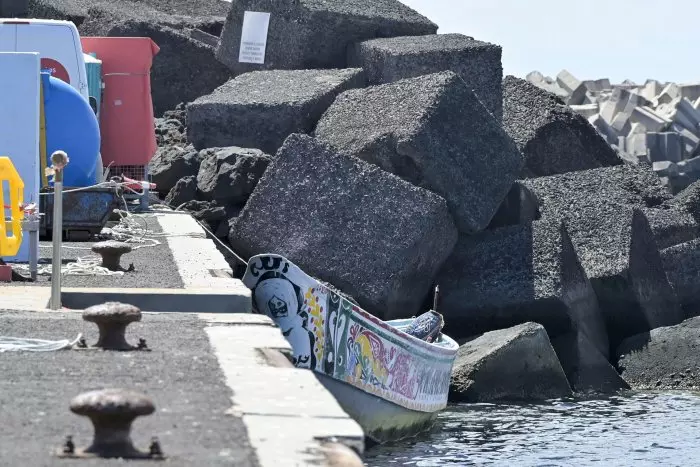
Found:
<box><xmin>0</xmin><ymin>312</ymin><xmax>258</xmax><ymax>466</ymax></box>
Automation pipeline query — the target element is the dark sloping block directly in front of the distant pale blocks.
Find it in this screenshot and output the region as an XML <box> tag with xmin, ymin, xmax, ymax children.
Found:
<box><xmin>503</xmin><ymin>76</ymin><xmax>622</xmax><ymax>177</ymax></box>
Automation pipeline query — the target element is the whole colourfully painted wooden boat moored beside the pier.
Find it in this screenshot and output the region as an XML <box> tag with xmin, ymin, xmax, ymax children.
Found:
<box><xmin>243</xmin><ymin>254</ymin><xmax>459</xmax><ymax>443</ymax></box>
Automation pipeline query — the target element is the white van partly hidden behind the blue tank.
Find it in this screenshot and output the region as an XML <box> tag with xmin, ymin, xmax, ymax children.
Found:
<box><xmin>0</xmin><ymin>18</ymin><xmax>90</xmax><ymax>102</ymax></box>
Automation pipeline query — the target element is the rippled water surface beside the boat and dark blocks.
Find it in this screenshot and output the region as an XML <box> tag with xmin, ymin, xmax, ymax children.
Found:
<box><xmin>365</xmin><ymin>393</ymin><xmax>700</xmax><ymax>467</ymax></box>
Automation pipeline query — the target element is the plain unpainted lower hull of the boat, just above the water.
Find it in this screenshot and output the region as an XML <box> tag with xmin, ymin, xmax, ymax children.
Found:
<box><xmin>316</xmin><ymin>372</ymin><xmax>439</xmax><ymax>444</ymax></box>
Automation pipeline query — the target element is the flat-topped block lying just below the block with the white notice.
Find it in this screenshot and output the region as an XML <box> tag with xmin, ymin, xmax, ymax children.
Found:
<box><xmin>187</xmin><ymin>68</ymin><xmax>365</xmax><ymax>154</ymax></box>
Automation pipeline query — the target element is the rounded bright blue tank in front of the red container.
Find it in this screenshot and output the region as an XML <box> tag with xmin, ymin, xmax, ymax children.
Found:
<box><xmin>41</xmin><ymin>72</ymin><xmax>101</xmax><ymax>187</ymax></box>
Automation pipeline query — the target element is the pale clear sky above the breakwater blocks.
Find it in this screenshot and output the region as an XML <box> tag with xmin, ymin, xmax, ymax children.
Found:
<box><xmin>401</xmin><ymin>0</ymin><xmax>700</xmax><ymax>83</ymax></box>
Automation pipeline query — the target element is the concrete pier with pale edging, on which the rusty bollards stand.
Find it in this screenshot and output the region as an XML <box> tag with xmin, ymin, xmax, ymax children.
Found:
<box><xmin>0</xmin><ymin>212</ymin><xmax>364</xmax><ymax>467</ymax></box>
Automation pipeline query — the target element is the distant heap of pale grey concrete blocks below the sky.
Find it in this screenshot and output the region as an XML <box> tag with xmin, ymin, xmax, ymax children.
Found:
<box><xmin>527</xmin><ymin>70</ymin><xmax>700</xmax><ymax>193</ymax></box>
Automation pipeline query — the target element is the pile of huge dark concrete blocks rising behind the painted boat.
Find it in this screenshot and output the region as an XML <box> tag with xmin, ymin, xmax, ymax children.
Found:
<box><xmin>144</xmin><ymin>0</ymin><xmax>700</xmax><ymax>401</ymax></box>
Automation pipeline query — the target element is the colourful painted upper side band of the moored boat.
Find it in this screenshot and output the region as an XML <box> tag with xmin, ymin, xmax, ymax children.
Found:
<box><xmin>243</xmin><ymin>255</ymin><xmax>454</xmax><ymax>411</ymax></box>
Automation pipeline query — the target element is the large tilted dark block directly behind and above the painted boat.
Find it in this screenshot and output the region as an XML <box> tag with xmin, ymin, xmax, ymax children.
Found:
<box><xmin>229</xmin><ymin>135</ymin><xmax>457</xmax><ymax>319</ymax></box>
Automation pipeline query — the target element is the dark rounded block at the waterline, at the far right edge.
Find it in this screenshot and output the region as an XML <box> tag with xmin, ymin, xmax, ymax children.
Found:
<box><xmin>617</xmin><ymin>318</ymin><xmax>700</xmax><ymax>390</ymax></box>
